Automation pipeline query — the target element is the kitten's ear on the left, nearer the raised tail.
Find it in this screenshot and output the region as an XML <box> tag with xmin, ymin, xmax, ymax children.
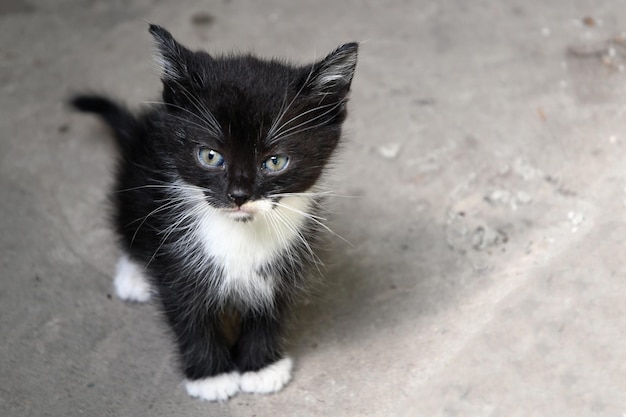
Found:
<box><xmin>150</xmin><ymin>25</ymin><xmax>192</xmax><ymax>82</ymax></box>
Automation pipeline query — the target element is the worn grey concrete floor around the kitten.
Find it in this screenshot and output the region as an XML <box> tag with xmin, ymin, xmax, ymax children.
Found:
<box><xmin>0</xmin><ymin>0</ymin><xmax>626</xmax><ymax>417</ymax></box>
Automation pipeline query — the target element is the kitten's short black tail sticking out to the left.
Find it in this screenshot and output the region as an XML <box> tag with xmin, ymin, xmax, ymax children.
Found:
<box><xmin>70</xmin><ymin>95</ymin><xmax>137</xmax><ymax>149</ymax></box>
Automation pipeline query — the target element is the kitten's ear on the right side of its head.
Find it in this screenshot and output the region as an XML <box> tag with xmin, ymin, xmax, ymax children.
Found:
<box><xmin>307</xmin><ymin>42</ymin><xmax>359</xmax><ymax>93</ymax></box>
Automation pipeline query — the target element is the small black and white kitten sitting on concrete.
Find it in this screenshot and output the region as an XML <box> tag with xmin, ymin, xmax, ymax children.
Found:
<box><xmin>73</xmin><ymin>25</ymin><xmax>358</xmax><ymax>400</ymax></box>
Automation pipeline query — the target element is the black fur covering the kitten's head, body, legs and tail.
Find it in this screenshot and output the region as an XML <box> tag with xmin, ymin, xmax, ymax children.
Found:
<box><xmin>72</xmin><ymin>25</ymin><xmax>357</xmax><ymax>388</ymax></box>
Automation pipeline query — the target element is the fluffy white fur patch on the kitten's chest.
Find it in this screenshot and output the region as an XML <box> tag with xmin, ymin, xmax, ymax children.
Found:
<box><xmin>188</xmin><ymin>196</ymin><xmax>311</xmax><ymax>307</ymax></box>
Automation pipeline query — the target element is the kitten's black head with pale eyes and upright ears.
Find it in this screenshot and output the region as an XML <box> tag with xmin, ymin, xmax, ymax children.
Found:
<box><xmin>150</xmin><ymin>25</ymin><xmax>358</xmax><ymax>219</ymax></box>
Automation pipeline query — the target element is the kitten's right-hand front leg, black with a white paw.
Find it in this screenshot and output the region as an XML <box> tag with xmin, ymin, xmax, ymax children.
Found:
<box><xmin>235</xmin><ymin>306</ymin><xmax>293</xmax><ymax>394</ymax></box>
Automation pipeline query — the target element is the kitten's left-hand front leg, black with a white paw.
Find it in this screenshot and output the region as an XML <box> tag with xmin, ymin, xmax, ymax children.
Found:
<box><xmin>159</xmin><ymin>287</ymin><xmax>239</xmax><ymax>401</ymax></box>
